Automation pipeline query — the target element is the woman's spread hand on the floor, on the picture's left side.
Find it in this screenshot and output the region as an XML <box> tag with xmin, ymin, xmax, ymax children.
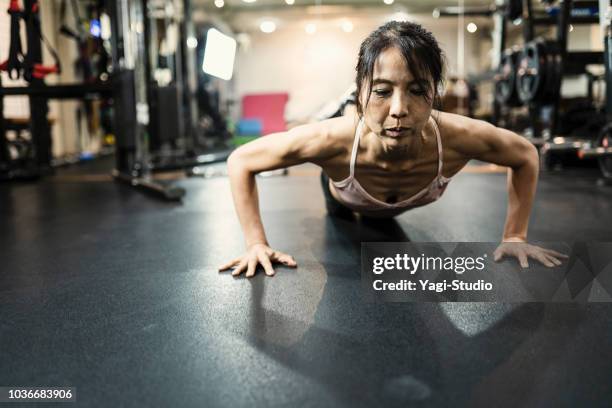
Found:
<box><xmin>219</xmin><ymin>244</ymin><xmax>297</xmax><ymax>278</ymax></box>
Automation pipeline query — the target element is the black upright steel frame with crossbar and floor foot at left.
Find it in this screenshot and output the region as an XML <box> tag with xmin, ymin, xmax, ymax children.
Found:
<box><xmin>0</xmin><ymin>0</ymin><xmax>185</xmax><ymax>200</ymax></box>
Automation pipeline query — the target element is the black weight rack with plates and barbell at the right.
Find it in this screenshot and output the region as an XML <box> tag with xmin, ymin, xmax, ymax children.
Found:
<box><xmin>434</xmin><ymin>0</ymin><xmax>612</xmax><ymax>178</ymax></box>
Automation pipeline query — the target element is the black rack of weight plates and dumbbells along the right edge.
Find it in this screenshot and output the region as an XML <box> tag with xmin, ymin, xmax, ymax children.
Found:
<box><xmin>494</xmin><ymin>0</ymin><xmax>612</xmax><ymax>179</ymax></box>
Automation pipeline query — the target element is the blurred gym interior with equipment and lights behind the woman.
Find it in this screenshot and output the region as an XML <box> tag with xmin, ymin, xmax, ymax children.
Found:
<box><xmin>0</xmin><ymin>0</ymin><xmax>610</xmax><ymax>191</ymax></box>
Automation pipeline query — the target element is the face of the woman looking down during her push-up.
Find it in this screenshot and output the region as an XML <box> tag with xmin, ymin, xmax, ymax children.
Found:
<box><xmin>361</xmin><ymin>47</ymin><xmax>433</xmax><ymax>152</ymax></box>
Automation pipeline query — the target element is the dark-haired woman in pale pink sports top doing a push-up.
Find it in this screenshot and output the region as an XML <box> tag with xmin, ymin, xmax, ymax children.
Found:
<box><xmin>219</xmin><ymin>21</ymin><xmax>565</xmax><ymax>277</ymax></box>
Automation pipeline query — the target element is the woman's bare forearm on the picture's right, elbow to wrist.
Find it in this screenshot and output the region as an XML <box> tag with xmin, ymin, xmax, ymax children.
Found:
<box><xmin>503</xmin><ymin>152</ymin><xmax>539</xmax><ymax>241</ymax></box>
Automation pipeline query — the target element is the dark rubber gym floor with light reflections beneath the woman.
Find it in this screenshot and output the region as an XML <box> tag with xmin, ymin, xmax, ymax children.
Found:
<box><xmin>0</xmin><ymin>160</ymin><xmax>612</xmax><ymax>407</ymax></box>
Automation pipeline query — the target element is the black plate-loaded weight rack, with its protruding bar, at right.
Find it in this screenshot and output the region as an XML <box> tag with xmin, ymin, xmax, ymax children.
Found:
<box><xmin>433</xmin><ymin>0</ymin><xmax>612</xmax><ymax>179</ymax></box>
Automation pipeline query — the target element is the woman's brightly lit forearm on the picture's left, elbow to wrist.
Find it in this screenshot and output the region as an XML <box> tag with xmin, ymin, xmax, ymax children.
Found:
<box><xmin>227</xmin><ymin>156</ymin><xmax>268</xmax><ymax>248</ymax></box>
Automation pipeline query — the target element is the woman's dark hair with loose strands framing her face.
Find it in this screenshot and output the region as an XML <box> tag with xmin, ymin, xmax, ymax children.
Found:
<box><xmin>355</xmin><ymin>21</ymin><xmax>444</xmax><ymax>116</ymax></box>
